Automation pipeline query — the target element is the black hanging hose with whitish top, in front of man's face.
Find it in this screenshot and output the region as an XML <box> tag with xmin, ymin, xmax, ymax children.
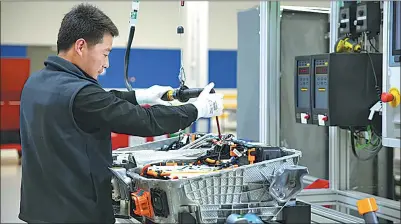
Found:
<box><xmin>124</xmin><ymin>0</ymin><xmax>139</xmax><ymax>91</ymax></box>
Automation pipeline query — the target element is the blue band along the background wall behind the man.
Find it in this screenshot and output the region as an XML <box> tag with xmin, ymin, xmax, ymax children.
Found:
<box><xmin>1</xmin><ymin>45</ymin><xmax>237</xmax><ymax>88</ymax></box>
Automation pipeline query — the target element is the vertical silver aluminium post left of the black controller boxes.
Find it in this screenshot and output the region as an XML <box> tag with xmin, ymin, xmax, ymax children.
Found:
<box><xmin>259</xmin><ymin>1</ymin><xmax>280</xmax><ymax>146</ymax></box>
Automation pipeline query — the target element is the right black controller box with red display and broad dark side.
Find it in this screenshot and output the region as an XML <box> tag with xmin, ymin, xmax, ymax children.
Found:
<box><xmin>311</xmin><ymin>53</ymin><xmax>382</xmax><ymax>128</ymax></box>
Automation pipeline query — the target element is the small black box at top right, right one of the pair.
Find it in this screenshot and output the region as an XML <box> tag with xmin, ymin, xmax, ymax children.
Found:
<box><xmin>354</xmin><ymin>1</ymin><xmax>381</xmax><ymax>37</ymax></box>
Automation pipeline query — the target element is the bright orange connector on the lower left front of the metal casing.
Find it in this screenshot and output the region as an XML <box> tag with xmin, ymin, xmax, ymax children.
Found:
<box><xmin>131</xmin><ymin>190</ymin><xmax>153</xmax><ymax>218</ymax></box>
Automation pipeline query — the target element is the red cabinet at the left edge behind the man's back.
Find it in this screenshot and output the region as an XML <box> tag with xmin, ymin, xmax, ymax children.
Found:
<box><xmin>0</xmin><ymin>58</ymin><xmax>30</xmax><ymax>131</ymax></box>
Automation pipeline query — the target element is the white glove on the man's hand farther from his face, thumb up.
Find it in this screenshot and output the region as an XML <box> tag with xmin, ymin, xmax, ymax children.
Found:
<box><xmin>192</xmin><ymin>82</ymin><xmax>224</xmax><ymax>119</ymax></box>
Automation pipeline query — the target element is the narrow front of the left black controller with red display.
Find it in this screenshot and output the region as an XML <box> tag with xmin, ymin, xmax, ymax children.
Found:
<box><xmin>294</xmin><ymin>56</ymin><xmax>313</xmax><ymax>124</ymax></box>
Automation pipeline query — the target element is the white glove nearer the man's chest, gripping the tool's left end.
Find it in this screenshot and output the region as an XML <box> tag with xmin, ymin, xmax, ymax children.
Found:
<box><xmin>135</xmin><ymin>85</ymin><xmax>173</xmax><ymax>106</ymax></box>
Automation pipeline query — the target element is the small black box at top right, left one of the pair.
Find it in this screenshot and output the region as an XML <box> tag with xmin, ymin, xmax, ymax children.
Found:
<box><xmin>339</xmin><ymin>2</ymin><xmax>356</xmax><ymax>35</ymax></box>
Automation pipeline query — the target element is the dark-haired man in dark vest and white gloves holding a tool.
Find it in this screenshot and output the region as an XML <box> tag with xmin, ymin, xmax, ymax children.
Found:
<box><xmin>19</xmin><ymin>4</ymin><xmax>223</xmax><ymax>223</ymax></box>
